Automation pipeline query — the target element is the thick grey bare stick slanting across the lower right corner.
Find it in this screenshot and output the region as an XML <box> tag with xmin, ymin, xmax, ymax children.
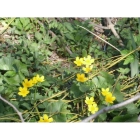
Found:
<box><xmin>81</xmin><ymin>93</ymin><xmax>140</xmax><ymax>122</ymax></box>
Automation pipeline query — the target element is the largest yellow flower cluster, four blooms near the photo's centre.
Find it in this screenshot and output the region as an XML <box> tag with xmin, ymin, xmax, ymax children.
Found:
<box><xmin>74</xmin><ymin>55</ymin><xmax>94</xmax><ymax>82</ymax></box>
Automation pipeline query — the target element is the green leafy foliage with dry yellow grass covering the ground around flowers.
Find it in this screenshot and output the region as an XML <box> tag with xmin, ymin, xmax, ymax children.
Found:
<box><xmin>0</xmin><ymin>18</ymin><xmax>140</xmax><ymax>122</ymax></box>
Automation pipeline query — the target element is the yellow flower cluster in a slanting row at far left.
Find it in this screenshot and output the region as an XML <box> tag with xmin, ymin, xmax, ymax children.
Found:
<box><xmin>18</xmin><ymin>74</ymin><xmax>44</xmax><ymax>97</ymax></box>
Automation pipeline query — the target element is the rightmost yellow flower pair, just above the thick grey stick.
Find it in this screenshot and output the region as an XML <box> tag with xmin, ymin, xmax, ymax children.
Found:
<box><xmin>102</xmin><ymin>88</ymin><xmax>116</xmax><ymax>103</ymax></box>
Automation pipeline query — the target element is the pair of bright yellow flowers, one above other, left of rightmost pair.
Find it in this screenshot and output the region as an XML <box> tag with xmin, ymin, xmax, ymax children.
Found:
<box><xmin>85</xmin><ymin>97</ymin><xmax>99</xmax><ymax>114</ymax></box>
